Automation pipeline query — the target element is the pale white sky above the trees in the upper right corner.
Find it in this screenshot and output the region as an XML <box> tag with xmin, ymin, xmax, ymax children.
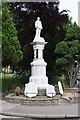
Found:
<box><xmin>59</xmin><ymin>0</ymin><xmax>80</xmax><ymax>24</ymax></box>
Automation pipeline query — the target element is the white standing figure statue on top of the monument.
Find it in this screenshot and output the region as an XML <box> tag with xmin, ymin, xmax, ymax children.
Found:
<box><xmin>35</xmin><ymin>17</ymin><xmax>43</xmax><ymax>37</ymax></box>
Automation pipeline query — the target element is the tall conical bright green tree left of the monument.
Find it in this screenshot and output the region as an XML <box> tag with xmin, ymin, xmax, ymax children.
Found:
<box><xmin>2</xmin><ymin>3</ymin><xmax>22</xmax><ymax>66</ymax></box>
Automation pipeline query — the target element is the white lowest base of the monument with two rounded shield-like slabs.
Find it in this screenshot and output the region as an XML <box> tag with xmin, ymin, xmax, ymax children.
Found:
<box><xmin>24</xmin><ymin>82</ymin><xmax>56</xmax><ymax>98</ymax></box>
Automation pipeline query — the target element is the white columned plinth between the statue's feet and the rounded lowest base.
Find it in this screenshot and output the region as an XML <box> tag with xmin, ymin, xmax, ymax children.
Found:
<box><xmin>29</xmin><ymin>37</ymin><xmax>48</xmax><ymax>88</ymax></box>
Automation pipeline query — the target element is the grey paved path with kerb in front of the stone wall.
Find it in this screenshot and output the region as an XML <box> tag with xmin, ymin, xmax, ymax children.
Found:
<box><xmin>0</xmin><ymin>100</ymin><xmax>80</xmax><ymax>118</ymax></box>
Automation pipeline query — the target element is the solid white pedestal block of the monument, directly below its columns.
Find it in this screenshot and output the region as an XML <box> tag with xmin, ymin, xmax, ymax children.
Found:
<box><xmin>29</xmin><ymin>59</ymin><xmax>48</xmax><ymax>87</ymax></box>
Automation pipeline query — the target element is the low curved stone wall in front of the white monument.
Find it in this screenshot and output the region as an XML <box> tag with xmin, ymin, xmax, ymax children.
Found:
<box><xmin>6</xmin><ymin>94</ymin><xmax>59</xmax><ymax>106</ymax></box>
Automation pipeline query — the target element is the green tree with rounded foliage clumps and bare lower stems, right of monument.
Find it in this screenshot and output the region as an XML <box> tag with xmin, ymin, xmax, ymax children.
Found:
<box><xmin>55</xmin><ymin>21</ymin><xmax>80</xmax><ymax>87</ymax></box>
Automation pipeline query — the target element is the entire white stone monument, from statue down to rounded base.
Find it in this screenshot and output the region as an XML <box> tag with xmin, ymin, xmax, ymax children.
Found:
<box><xmin>24</xmin><ymin>17</ymin><xmax>56</xmax><ymax>97</ymax></box>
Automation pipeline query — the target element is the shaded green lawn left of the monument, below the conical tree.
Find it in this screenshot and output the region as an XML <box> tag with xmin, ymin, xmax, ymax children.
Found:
<box><xmin>0</xmin><ymin>74</ymin><xmax>25</xmax><ymax>93</ymax></box>
